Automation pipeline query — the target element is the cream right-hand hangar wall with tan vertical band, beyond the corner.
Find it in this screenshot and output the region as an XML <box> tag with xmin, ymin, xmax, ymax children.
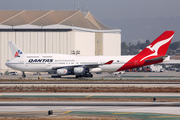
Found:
<box><xmin>75</xmin><ymin>31</ymin><xmax>121</xmax><ymax>56</ymax></box>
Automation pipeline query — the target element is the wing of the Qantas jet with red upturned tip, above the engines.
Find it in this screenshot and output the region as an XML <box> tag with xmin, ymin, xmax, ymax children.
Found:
<box><xmin>52</xmin><ymin>60</ymin><xmax>114</xmax><ymax>70</ymax></box>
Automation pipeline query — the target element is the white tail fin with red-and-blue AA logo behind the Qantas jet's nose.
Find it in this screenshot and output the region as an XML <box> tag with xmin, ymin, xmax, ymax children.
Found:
<box><xmin>8</xmin><ymin>41</ymin><xmax>23</xmax><ymax>57</ymax></box>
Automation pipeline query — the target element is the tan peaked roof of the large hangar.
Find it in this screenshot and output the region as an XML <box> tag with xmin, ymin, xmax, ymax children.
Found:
<box><xmin>0</xmin><ymin>10</ymin><xmax>113</xmax><ymax>30</ymax></box>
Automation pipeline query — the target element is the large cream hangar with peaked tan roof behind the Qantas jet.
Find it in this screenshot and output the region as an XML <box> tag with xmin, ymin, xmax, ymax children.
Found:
<box><xmin>0</xmin><ymin>10</ymin><xmax>121</xmax><ymax>71</ymax></box>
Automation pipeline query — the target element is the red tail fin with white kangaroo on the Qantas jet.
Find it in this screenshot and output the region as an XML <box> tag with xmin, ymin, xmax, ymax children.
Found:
<box><xmin>117</xmin><ymin>31</ymin><xmax>175</xmax><ymax>71</ymax></box>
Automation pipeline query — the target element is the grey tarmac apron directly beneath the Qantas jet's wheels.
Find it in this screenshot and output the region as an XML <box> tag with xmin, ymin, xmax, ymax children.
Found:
<box><xmin>0</xmin><ymin>71</ymin><xmax>180</xmax><ymax>80</ymax></box>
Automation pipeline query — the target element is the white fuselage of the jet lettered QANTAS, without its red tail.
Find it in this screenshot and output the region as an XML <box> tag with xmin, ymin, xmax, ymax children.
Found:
<box><xmin>6</xmin><ymin>54</ymin><xmax>133</xmax><ymax>72</ymax></box>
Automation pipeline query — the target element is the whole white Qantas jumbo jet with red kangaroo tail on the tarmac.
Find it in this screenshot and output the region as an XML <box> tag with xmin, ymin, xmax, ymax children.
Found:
<box><xmin>6</xmin><ymin>31</ymin><xmax>175</xmax><ymax>78</ymax></box>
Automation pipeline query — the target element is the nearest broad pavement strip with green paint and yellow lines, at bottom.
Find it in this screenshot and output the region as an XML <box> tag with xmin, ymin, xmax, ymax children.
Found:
<box><xmin>0</xmin><ymin>101</ymin><xmax>180</xmax><ymax>120</ymax></box>
